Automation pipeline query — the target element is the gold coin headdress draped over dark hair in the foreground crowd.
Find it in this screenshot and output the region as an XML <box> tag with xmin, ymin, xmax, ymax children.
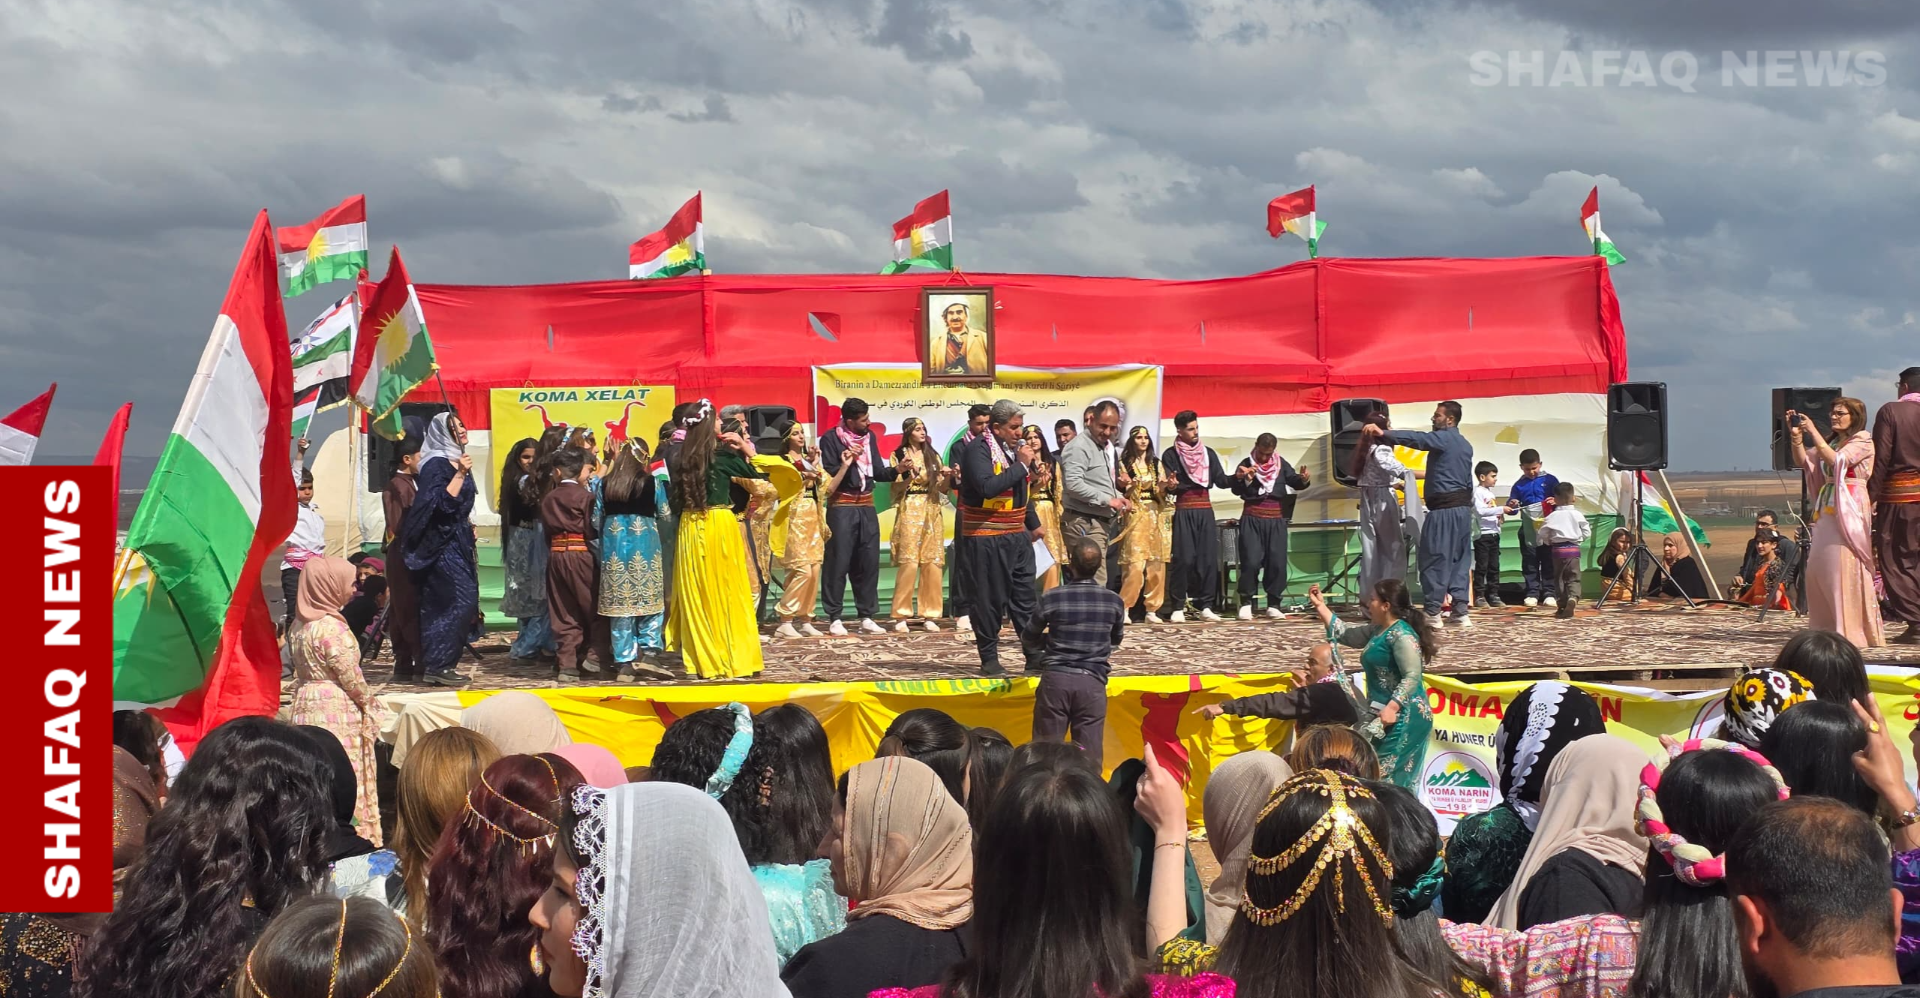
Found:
<box><xmin>1240</xmin><ymin>770</ymin><xmax>1394</xmax><ymax>925</ymax></box>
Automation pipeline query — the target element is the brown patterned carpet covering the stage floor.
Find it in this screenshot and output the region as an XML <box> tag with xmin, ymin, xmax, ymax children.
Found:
<box><xmin>367</xmin><ymin>603</ymin><xmax>1920</xmax><ymax>693</ymax></box>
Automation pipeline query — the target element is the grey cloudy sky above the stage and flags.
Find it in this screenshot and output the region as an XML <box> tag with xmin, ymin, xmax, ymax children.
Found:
<box><xmin>0</xmin><ymin>0</ymin><xmax>1920</xmax><ymax>470</ymax></box>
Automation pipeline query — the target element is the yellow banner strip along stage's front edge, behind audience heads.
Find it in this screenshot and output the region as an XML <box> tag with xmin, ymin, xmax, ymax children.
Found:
<box><xmin>384</xmin><ymin>670</ymin><xmax>1920</xmax><ymax>831</ymax></box>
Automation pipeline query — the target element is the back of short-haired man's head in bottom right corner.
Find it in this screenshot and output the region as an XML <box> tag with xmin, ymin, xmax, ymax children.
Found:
<box><xmin>1726</xmin><ymin>796</ymin><xmax>1920</xmax><ymax>998</ymax></box>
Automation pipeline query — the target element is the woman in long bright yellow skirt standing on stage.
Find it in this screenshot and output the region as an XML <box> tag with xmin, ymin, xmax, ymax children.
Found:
<box><xmin>666</xmin><ymin>399</ymin><xmax>766</xmax><ymax>679</ymax></box>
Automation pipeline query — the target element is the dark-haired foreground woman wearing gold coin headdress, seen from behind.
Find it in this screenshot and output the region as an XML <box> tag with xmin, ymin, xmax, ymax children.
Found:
<box><xmin>1150</xmin><ymin>770</ymin><xmax>1446</xmax><ymax>998</ymax></box>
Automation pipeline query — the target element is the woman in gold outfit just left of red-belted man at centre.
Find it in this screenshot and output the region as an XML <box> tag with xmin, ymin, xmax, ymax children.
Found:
<box><xmin>893</xmin><ymin>418</ymin><xmax>947</xmax><ymax>631</ymax></box>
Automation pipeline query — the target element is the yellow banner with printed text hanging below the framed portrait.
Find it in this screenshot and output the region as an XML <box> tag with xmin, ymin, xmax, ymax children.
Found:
<box><xmin>814</xmin><ymin>365</ymin><xmax>1160</xmax><ymax>525</ymax></box>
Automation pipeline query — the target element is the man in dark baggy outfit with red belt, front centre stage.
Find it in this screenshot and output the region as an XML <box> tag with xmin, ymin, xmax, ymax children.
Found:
<box><xmin>960</xmin><ymin>399</ymin><xmax>1041</xmax><ymax>676</ymax></box>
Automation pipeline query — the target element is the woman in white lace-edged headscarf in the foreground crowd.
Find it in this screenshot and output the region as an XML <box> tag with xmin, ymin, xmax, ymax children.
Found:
<box><xmin>528</xmin><ymin>783</ymin><xmax>787</xmax><ymax>998</ymax></box>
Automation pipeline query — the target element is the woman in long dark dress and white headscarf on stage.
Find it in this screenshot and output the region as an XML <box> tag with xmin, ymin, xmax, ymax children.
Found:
<box><xmin>399</xmin><ymin>411</ymin><xmax>480</xmax><ymax>687</ymax></box>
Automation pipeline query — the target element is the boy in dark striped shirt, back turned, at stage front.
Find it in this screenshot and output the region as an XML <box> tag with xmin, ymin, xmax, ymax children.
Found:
<box><xmin>1027</xmin><ymin>537</ymin><xmax>1127</xmax><ymax>766</ymax></box>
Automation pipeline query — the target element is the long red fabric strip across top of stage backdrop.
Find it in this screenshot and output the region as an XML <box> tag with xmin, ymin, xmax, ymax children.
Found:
<box><xmin>415</xmin><ymin>255</ymin><xmax>1626</xmax><ymax>430</ymax></box>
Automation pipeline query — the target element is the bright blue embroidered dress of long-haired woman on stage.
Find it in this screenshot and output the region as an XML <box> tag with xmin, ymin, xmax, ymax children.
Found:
<box><xmin>593</xmin><ymin>476</ymin><xmax>666</xmax><ymax>664</ymax></box>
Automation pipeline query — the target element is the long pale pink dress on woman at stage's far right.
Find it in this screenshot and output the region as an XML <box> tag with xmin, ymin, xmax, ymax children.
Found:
<box><xmin>1801</xmin><ymin>430</ymin><xmax>1887</xmax><ymax>649</ymax></box>
